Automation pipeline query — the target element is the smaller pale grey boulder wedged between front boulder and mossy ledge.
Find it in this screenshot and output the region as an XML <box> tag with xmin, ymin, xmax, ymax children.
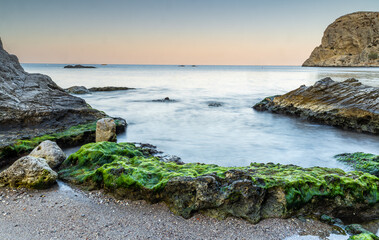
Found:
<box><xmin>29</xmin><ymin>140</ymin><xmax>66</xmax><ymax>169</ymax></box>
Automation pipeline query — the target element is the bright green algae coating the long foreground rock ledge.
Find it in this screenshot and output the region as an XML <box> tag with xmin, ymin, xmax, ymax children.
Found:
<box><xmin>59</xmin><ymin>142</ymin><xmax>379</xmax><ymax>209</ymax></box>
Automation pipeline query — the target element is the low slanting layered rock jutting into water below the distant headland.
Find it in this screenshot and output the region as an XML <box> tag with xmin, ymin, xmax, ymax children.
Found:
<box><xmin>253</xmin><ymin>78</ymin><xmax>379</xmax><ymax>134</ymax></box>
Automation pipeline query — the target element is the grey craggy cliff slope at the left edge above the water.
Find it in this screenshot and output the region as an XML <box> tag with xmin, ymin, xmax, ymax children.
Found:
<box><xmin>0</xmin><ymin>40</ymin><xmax>104</xmax><ymax>146</ymax></box>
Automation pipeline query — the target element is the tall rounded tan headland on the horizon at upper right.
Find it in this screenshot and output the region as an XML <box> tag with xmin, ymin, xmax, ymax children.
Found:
<box><xmin>303</xmin><ymin>12</ymin><xmax>379</xmax><ymax>67</ymax></box>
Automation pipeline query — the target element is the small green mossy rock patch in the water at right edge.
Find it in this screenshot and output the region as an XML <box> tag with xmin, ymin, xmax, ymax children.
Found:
<box><xmin>335</xmin><ymin>152</ymin><xmax>379</xmax><ymax>177</ymax></box>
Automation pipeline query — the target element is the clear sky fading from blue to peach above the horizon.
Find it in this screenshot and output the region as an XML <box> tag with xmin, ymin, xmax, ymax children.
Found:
<box><xmin>0</xmin><ymin>0</ymin><xmax>379</xmax><ymax>65</ymax></box>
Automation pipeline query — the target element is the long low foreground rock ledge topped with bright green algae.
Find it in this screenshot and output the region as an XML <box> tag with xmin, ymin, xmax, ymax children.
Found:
<box><xmin>59</xmin><ymin>142</ymin><xmax>379</xmax><ymax>222</ymax></box>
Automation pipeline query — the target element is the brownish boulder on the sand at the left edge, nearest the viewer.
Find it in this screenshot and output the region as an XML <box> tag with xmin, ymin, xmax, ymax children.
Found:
<box><xmin>0</xmin><ymin>156</ymin><xmax>58</xmax><ymax>189</ymax></box>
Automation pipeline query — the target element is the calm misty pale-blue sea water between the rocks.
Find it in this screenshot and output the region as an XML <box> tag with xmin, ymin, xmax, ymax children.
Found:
<box><xmin>23</xmin><ymin>64</ymin><xmax>379</xmax><ymax>170</ymax></box>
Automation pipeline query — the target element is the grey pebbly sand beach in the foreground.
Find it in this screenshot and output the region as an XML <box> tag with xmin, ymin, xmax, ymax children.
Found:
<box><xmin>0</xmin><ymin>182</ymin><xmax>331</xmax><ymax>240</ymax></box>
